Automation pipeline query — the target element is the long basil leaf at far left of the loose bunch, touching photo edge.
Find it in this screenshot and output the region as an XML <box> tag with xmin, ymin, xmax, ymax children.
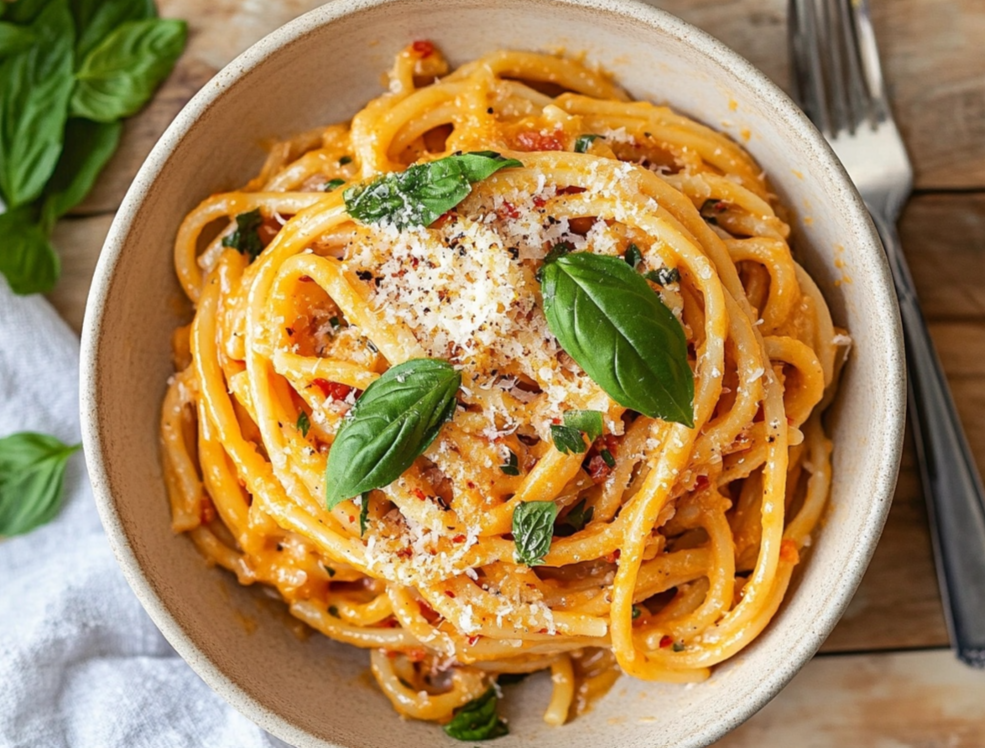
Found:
<box><xmin>0</xmin><ymin>0</ymin><xmax>75</xmax><ymax>208</ymax></box>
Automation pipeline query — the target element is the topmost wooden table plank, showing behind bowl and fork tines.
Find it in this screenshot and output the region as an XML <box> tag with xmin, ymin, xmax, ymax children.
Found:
<box><xmin>77</xmin><ymin>0</ymin><xmax>985</xmax><ymax>214</ymax></box>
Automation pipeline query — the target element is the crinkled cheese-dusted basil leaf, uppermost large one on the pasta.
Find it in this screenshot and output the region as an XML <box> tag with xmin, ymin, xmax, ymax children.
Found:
<box><xmin>343</xmin><ymin>151</ymin><xmax>523</xmax><ymax>230</ymax></box>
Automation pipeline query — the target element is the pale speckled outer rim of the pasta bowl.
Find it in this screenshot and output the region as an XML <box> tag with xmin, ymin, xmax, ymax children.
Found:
<box><xmin>80</xmin><ymin>0</ymin><xmax>906</xmax><ymax>748</ymax></box>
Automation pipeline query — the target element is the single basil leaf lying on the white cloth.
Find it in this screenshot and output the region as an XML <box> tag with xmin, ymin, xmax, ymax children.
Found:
<box><xmin>0</xmin><ymin>432</ymin><xmax>82</xmax><ymax>536</ymax></box>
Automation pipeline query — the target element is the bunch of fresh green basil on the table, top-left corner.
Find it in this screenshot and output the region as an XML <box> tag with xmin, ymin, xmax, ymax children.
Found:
<box><xmin>0</xmin><ymin>0</ymin><xmax>187</xmax><ymax>294</ymax></box>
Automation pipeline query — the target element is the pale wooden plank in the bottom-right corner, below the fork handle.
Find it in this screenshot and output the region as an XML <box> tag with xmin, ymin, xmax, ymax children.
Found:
<box><xmin>714</xmin><ymin>650</ymin><xmax>985</xmax><ymax>748</ymax></box>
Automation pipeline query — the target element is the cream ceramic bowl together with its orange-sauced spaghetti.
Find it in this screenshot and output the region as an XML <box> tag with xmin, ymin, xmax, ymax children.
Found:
<box><xmin>82</xmin><ymin>0</ymin><xmax>904</xmax><ymax>748</ymax></box>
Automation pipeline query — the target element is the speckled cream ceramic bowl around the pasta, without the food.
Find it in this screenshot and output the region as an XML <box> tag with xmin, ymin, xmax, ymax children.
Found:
<box><xmin>82</xmin><ymin>0</ymin><xmax>904</xmax><ymax>748</ymax></box>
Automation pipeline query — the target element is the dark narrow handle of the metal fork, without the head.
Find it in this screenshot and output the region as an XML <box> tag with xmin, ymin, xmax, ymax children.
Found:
<box><xmin>872</xmin><ymin>211</ymin><xmax>985</xmax><ymax>667</ymax></box>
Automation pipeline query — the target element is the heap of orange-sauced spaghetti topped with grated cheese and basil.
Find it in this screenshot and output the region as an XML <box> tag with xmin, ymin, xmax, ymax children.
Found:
<box><xmin>161</xmin><ymin>42</ymin><xmax>849</xmax><ymax>739</ymax></box>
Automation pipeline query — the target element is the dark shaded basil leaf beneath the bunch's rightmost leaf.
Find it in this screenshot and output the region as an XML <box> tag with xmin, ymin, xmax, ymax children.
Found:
<box><xmin>42</xmin><ymin>118</ymin><xmax>123</xmax><ymax>229</ymax></box>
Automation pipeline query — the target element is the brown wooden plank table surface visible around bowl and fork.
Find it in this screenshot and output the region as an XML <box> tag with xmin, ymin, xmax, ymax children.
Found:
<box><xmin>50</xmin><ymin>0</ymin><xmax>985</xmax><ymax>748</ymax></box>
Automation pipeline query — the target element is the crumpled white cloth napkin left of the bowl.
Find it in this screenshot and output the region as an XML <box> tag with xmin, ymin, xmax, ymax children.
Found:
<box><xmin>0</xmin><ymin>277</ymin><xmax>285</xmax><ymax>748</ymax></box>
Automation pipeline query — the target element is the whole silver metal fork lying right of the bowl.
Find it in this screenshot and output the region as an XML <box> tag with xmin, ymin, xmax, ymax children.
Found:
<box><xmin>789</xmin><ymin>0</ymin><xmax>985</xmax><ymax>667</ymax></box>
